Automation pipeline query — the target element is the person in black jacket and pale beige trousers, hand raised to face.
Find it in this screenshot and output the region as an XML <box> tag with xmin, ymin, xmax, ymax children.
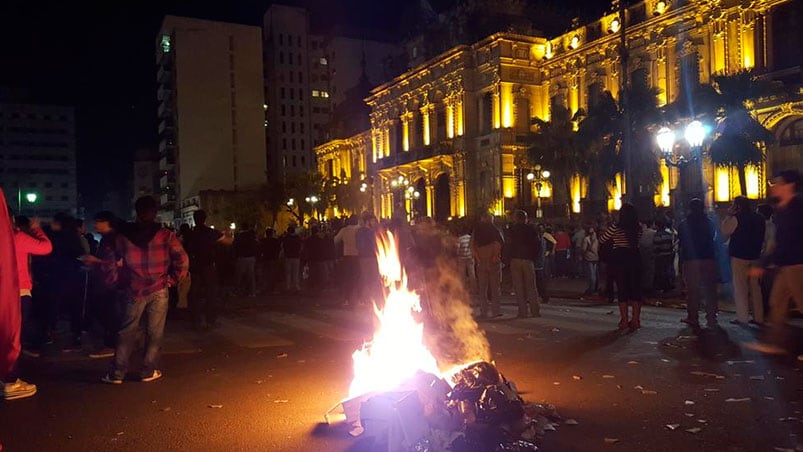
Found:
<box><xmin>722</xmin><ymin>196</ymin><xmax>764</xmax><ymax>325</ymax></box>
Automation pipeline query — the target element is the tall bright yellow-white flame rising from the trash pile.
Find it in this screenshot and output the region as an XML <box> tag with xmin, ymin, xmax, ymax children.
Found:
<box><xmin>349</xmin><ymin>232</ymin><xmax>440</xmax><ymax>398</ymax></box>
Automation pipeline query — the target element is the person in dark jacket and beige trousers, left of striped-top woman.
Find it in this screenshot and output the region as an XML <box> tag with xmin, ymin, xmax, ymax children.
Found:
<box><xmin>506</xmin><ymin>210</ymin><xmax>541</xmax><ymax>318</ymax></box>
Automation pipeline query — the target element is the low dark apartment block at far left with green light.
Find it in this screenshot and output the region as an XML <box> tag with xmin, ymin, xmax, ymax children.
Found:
<box><xmin>0</xmin><ymin>103</ymin><xmax>77</xmax><ymax>218</ymax></box>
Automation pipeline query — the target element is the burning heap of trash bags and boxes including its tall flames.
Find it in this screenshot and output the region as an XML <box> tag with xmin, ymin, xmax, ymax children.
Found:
<box><xmin>325</xmin><ymin>233</ymin><xmax>564</xmax><ymax>452</ymax></box>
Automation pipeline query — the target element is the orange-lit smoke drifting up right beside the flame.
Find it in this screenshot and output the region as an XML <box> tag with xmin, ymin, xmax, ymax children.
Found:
<box><xmin>408</xmin><ymin>224</ymin><xmax>491</xmax><ymax>369</ymax></box>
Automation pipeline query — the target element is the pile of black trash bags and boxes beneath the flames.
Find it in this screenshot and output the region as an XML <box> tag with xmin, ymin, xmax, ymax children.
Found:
<box><xmin>326</xmin><ymin>362</ymin><xmax>564</xmax><ymax>452</ymax></box>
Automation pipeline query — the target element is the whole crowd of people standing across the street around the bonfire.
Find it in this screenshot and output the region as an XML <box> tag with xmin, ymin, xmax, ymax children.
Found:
<box><xmin>0</xmin><ymin>171</ymin><xmax>803</xmax><ymax>399</ymax></box>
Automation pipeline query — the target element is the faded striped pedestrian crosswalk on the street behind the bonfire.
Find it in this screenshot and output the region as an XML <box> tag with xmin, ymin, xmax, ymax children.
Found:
<box><xmin>160</xmin><ymin>301</ymin><xmax>727</xmax><ymax>353</ymax></box>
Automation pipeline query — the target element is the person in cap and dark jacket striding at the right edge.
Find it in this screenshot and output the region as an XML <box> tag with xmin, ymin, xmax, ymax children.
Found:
<box><xmin>748</xmin><ymin>170</ymin><xmax>803</xmax><ymax>361</ymax></box>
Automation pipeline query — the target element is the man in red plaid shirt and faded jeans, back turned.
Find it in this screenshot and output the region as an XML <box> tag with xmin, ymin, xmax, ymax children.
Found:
<box><xmin>102</xmin><ymin>196</ymin><xmax>189</xmax><ymax>384</ymax></box>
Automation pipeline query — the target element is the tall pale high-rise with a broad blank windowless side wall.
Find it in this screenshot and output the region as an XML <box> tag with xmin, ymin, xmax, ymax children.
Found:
<box><xmin>156</xmin><ymin>16</ymin><xmax>266</xmax><ymax>222</ymax></box>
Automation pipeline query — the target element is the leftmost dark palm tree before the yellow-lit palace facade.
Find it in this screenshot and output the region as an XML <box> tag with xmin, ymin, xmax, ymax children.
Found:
<box><xmin>527</xmin><ymin>105</ymin><xmax>586</xmax><ymax>214</ymax></box>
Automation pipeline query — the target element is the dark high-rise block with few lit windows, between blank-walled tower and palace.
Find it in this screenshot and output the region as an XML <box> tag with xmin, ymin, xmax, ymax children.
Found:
<box><xmin>263</xmin><ymin>5</ymin><xmax>400</xmax><ymax>180</ymax></box>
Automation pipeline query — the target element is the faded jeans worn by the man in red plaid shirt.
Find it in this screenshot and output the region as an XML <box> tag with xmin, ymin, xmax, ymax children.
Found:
<box><xmin>112</xmin><ymin>289</ymin><xmax>168</xmax><ymax>378</ymax></box>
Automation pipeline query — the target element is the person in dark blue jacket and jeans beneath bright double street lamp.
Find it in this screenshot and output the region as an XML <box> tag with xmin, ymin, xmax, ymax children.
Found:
<box><xmin>678</xmin><ymin>198</ymin><xmax>719</xmax><ymax>330</ymax></box>
